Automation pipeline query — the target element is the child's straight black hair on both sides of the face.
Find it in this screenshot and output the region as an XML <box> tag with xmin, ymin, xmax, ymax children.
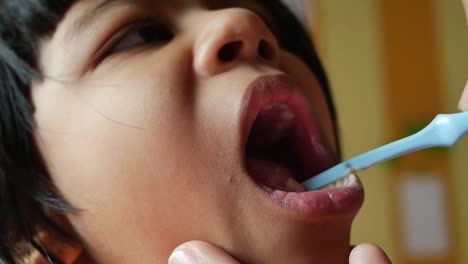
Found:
<box><xmin>0</xmin><ymin>0</ymin><xmax>335</xmax><ymax>263</ymax></box>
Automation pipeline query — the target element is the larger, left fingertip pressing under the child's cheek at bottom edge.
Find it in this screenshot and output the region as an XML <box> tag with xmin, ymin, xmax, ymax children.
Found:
<box><xmin>168</xmin><ymin>241</ymin><xmax>239</xmax><ymax>264</ymax></box>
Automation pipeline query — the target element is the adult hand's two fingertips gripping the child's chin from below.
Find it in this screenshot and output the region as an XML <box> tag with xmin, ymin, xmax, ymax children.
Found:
<box><xmin>169</xmin><ymin>241</ymin><xmax>391</xmax><ymax>264</ymax></box>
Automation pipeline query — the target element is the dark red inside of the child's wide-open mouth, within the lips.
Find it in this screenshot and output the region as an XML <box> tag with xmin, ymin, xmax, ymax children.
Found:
<box><xmin>244</xmin><ymin>77</ymin><xmax>338</xmax><ymax>192</ymax></box>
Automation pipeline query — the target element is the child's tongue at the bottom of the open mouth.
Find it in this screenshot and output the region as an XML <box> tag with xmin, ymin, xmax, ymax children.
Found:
<box><xmin>247</xmin><ymin>158</ymin><xmax>304</xmax><ymax>192</ymax></box>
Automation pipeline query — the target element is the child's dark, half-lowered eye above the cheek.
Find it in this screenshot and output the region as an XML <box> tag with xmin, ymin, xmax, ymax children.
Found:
<box><xmin>105</xmin><ymin>20</ymin><xmax>174</xmax><ymax>56</ymax></box>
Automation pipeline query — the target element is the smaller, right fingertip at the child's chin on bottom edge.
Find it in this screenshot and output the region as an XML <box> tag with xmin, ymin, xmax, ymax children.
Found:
<box><xmin>349</xmin><ymin>244</ymin><xmax>392</xmax><ymax>264</ymax></box>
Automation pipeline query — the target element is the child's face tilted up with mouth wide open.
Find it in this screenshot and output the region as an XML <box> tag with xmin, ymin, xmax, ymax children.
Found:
<box><xmin>33</xmin><ymin>0</ymin><xmax>363</xmax><ymax>263</ymax></box>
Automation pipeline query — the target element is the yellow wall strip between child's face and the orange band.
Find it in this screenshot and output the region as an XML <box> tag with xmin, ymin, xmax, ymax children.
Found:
<box><xmin>315</xmin><ymin>0</ymin><xmax>398</xmax><ymax>263</ymax></box>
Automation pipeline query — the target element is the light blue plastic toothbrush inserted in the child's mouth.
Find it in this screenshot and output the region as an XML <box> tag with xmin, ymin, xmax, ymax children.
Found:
<box><xmin>302</xmin><ymin>111</ymin><xmax>468</xmax><ymax>191</ymax></box>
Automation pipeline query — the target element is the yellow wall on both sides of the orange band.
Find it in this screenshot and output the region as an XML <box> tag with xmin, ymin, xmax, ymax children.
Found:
<box><xmin>313</xmin><ymin>0</ymin><xmax>468</xmax><ymax>263</ymax></box>
